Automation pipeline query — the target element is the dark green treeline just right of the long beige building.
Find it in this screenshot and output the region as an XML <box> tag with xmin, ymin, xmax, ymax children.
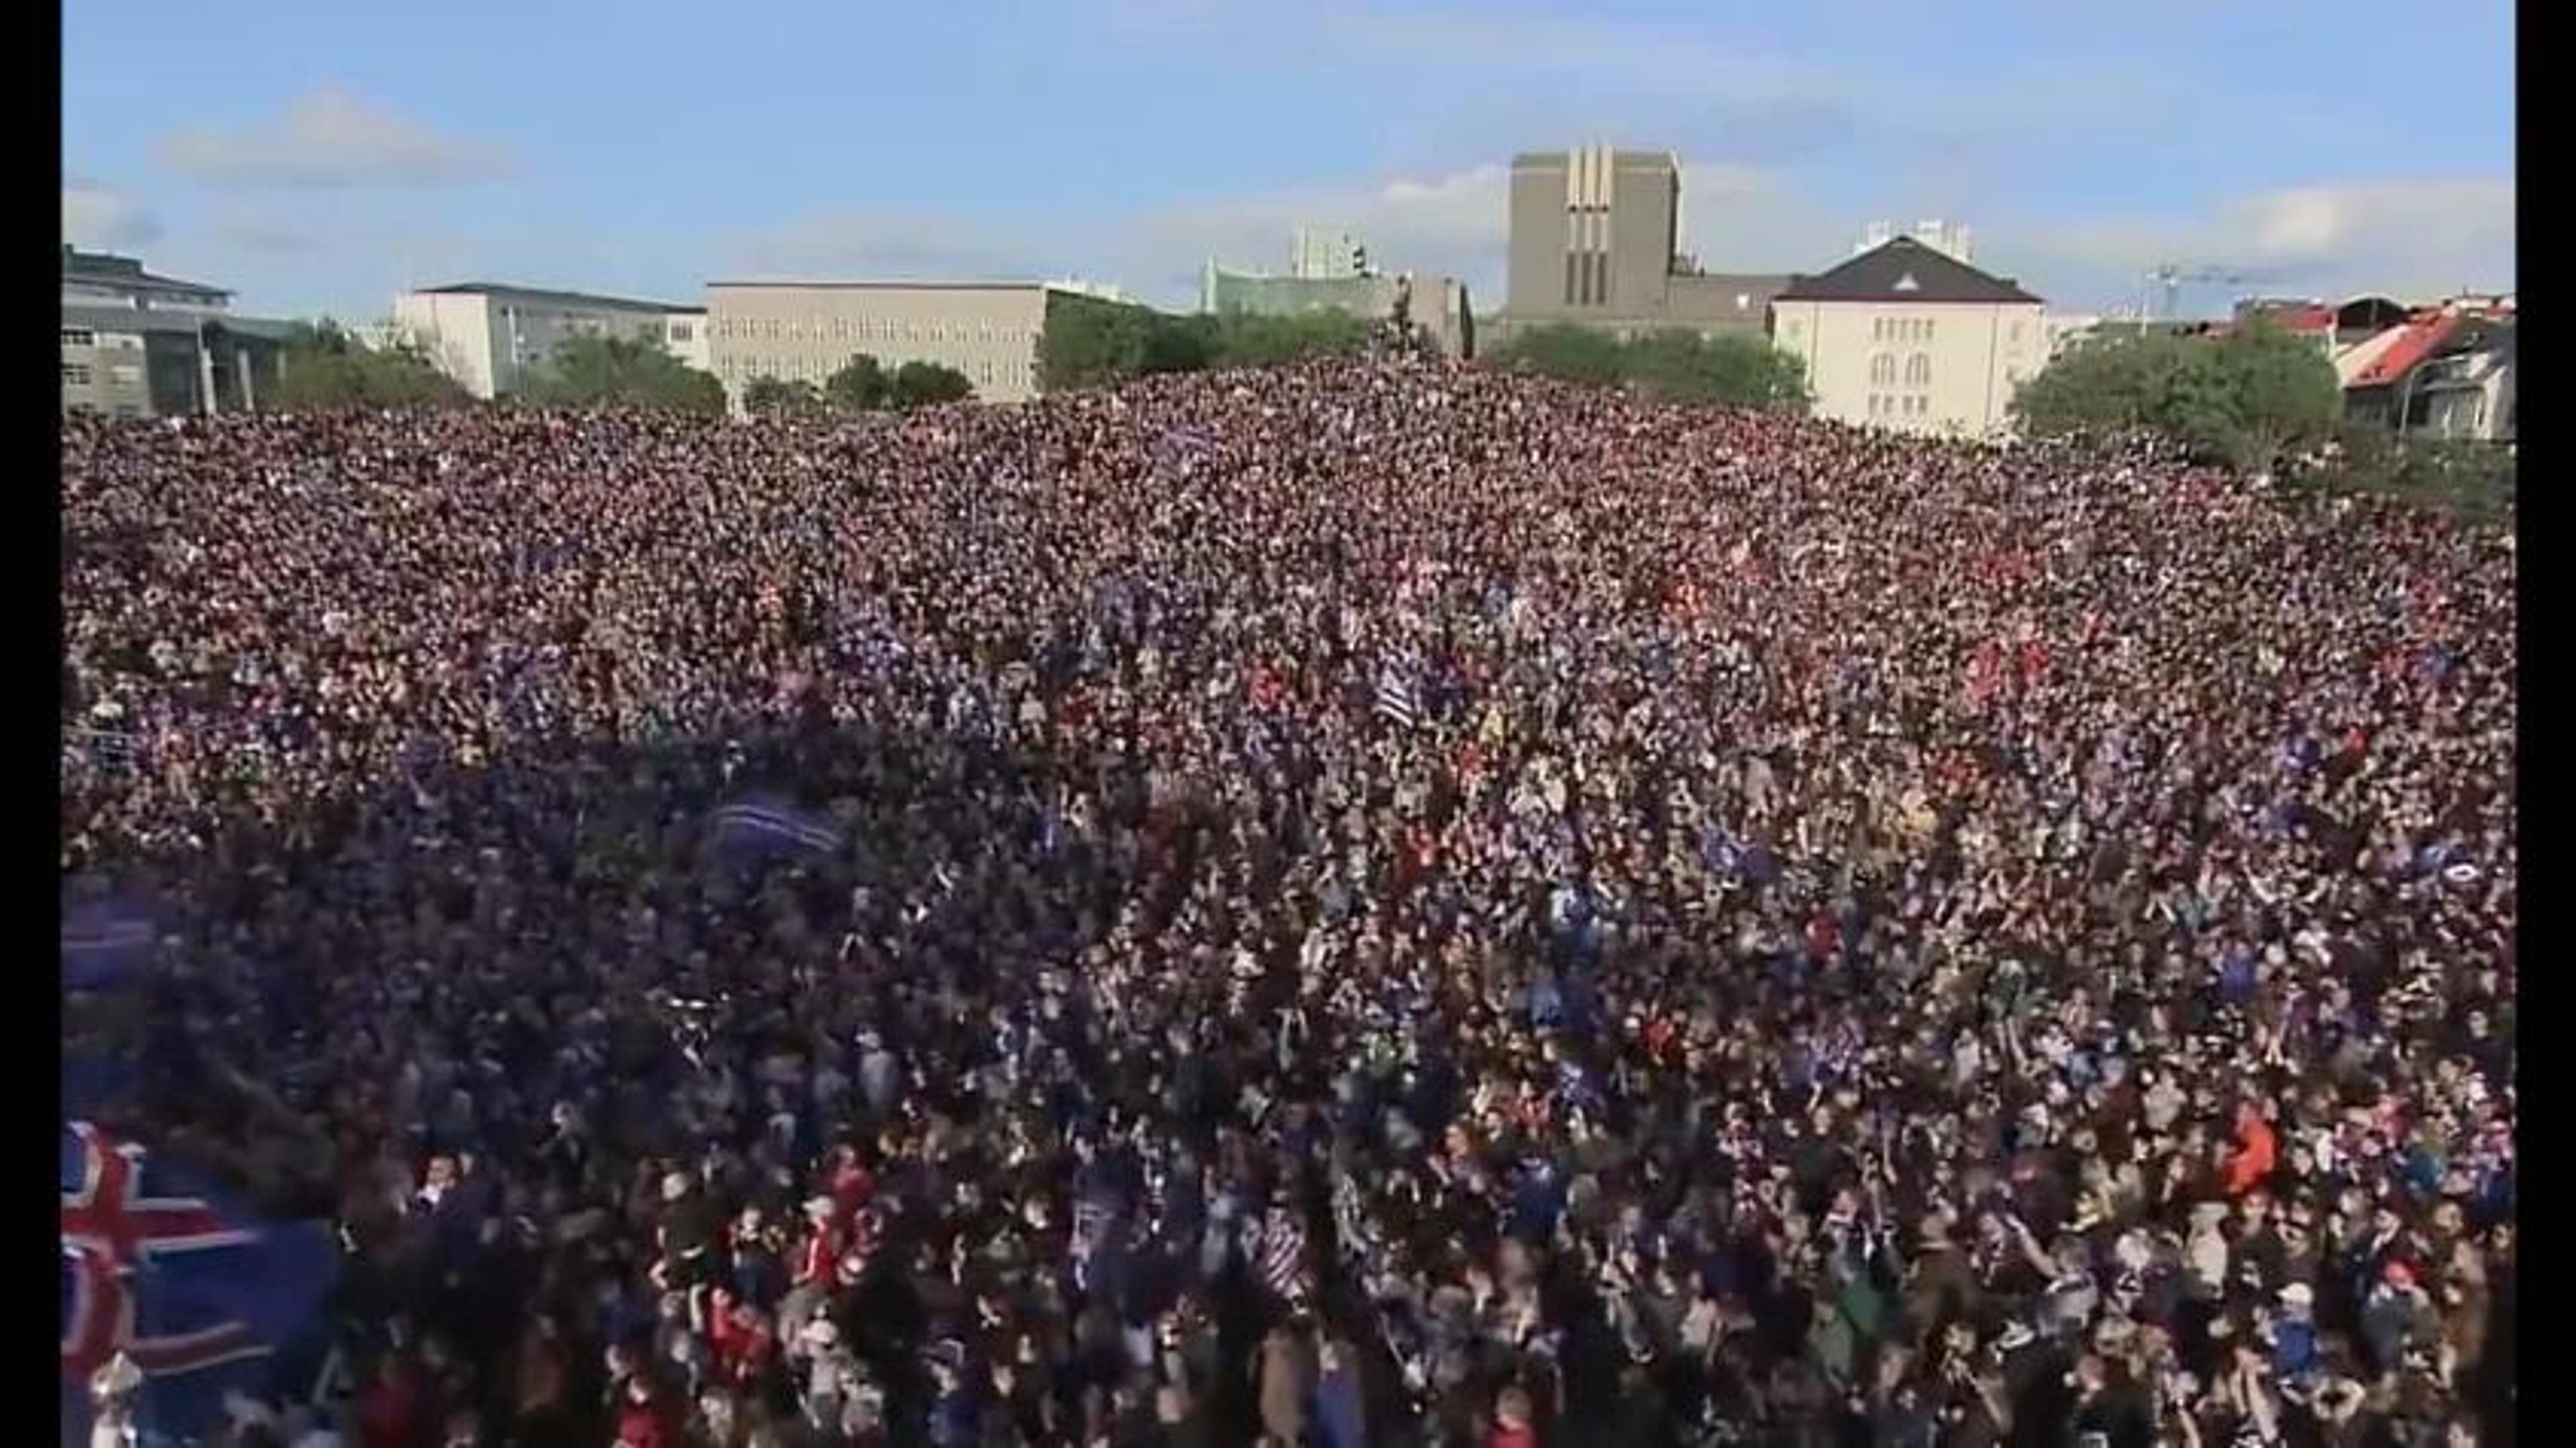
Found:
<box><xmin>1038</xmin><ymin>294</ymin><xmax>1371</xmax><ymax>392</ymax></box>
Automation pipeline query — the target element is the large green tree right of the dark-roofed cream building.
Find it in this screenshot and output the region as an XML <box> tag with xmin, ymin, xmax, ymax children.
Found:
<box><xmin>2012</xmin><ymin>322</ymin><xmax>2344</xmax><ymax>472</ymax></box>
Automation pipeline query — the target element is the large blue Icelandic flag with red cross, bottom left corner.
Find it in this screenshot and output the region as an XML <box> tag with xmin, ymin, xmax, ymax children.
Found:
<box><xmin>62</xmin><ymin>1121</ymin><xmax>337</xmax><ymax>1443</ymax></box>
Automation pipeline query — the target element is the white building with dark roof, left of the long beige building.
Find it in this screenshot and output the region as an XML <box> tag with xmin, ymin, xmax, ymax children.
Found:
<box><xmin>394</xmin><ymin>281</ymin><xmax>708</xmax><ymax>399</ymax></box>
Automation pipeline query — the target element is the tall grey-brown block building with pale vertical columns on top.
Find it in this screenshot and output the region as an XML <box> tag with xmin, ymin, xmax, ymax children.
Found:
<box><xmin>1489</xmin><ymin>147</ymin><xmax>1793</xmax><ymax>340</ymax></box>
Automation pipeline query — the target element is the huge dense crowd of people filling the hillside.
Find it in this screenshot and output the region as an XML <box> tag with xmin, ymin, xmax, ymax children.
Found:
<box><xmin>62</xmin><ymin>356</ymin><xmax>2517</xmax><ymax>1448</ymax></box>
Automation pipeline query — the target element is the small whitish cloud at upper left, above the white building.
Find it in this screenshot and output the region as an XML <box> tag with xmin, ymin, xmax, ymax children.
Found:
<box><xmin>162</xmin><ymin>88</ymin><xmax>507</xmax><ymax>191</ymax></box>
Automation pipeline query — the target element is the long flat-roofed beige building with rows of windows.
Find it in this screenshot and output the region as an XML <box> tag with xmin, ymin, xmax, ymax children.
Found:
<box><xmin>706</xmin><ymin>281</ymin><xmax>1059</xmax><ymax>407</ymax></box>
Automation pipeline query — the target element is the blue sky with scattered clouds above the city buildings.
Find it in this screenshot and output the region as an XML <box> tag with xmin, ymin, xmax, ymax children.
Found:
<box><xmin>62</xmin><ymin>0</ymin><xmax>2514</xmax><ymax>319</ymax></box>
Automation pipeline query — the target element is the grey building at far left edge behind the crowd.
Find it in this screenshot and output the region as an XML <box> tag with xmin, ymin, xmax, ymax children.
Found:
<box><xmin>59</xmin><ymin>248</ymin><xmax>286</xmax><ymax>417</ymax></box>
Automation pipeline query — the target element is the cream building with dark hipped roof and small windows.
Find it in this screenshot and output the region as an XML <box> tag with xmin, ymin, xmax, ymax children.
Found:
<box><xmin>1772</xmin><ymin>237</ymin><xmax>2051</xmax><ymax>438</ymax></box>
